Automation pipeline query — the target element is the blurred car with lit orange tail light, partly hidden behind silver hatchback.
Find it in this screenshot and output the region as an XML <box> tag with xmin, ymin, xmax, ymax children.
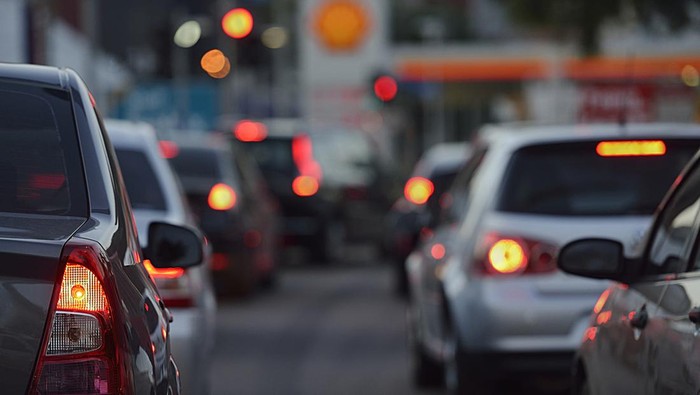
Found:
<box><xmin>383</xmin><ymin>142</ymin><xmax>471</xmax><ymax>296</ymax></box>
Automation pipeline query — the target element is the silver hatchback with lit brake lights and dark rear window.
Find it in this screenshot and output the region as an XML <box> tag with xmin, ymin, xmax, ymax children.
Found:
<box><xmin>406</xmin><ymin>124</ymin><xmax>700</xmax><ymax>393</ymax></box>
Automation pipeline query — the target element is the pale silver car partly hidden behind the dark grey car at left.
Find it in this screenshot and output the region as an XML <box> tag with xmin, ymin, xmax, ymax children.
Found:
<box><xmin>105</xmin><ymin>119</ymin><xmax>216</xmax><ymax>394</ymax></box>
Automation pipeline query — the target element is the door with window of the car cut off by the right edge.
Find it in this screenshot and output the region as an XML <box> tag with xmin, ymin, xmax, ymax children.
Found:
<box><xmin>648</xmin><ymin>162</ymin><xmax>700</xmax><ymax>394</ymax></box>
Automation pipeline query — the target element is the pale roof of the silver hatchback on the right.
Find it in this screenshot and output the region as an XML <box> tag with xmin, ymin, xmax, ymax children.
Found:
<box><xmin>476</xmin><ymin>123</ymin><xmax>700</xmax><ymax>147</ymax></box>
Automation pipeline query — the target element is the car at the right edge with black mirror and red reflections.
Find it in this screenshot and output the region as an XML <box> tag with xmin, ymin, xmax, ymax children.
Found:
<box><xmin>558</xmin><ymin>141</ymin><xmax>700</xmax><ymax>394</ymax></box>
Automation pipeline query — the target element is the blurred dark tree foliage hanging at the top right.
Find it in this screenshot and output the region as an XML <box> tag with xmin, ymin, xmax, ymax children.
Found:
<box><xmin>500</xmin><ymin>0</ymin><xmax>700</xmax><ymax>56</ymax></box>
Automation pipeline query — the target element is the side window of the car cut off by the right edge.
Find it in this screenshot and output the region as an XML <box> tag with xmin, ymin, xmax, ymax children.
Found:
<box><xmin>649</xmin><ymin>168</ymin><xmax>700</xmax><ymax>273</ymax></box>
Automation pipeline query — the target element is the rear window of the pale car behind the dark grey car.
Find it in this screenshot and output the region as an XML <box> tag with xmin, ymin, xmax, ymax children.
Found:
<box><xmin>115</xmin><ymin>148</ymin><xmax>166</xmax><ymax>211</ymax></box>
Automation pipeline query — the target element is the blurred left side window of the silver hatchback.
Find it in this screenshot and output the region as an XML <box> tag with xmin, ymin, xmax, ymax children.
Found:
<box><xmin>440</xmin><ymin>148</ymin><xmax>486</xmax><ymax>223</ymax></box>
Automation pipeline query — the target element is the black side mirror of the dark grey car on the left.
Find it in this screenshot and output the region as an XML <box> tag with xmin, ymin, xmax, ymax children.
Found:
<box><xmin>145</xmin><ymin>222</ymin><xmax>204</xmax><ymax>268</ymax></box>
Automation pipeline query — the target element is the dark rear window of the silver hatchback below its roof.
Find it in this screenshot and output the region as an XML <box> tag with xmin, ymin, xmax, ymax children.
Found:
<box><xmin>497</xmin><ymin>140</ymin><xmax>700</xmax><ymax>216</ymax></box>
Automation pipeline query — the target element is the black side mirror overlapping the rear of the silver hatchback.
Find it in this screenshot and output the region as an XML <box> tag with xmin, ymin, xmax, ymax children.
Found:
<box><xmin>557</xmin><ymin>239</ymin><xmax>625</xmax><ymax>282</ymax></box>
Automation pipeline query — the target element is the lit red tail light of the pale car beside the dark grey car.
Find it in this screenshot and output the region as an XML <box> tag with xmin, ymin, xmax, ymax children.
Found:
<box><xmin>143</xmin><ymin>259</ymin><xmax>194</xmax><ymax>307</ymax></box>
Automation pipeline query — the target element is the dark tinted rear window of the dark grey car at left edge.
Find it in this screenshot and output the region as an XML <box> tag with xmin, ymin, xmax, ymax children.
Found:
<box><xmin>0</xmin><ymin>83</ymin><xmax>88</xmax><ymax>217</ymax></box>
